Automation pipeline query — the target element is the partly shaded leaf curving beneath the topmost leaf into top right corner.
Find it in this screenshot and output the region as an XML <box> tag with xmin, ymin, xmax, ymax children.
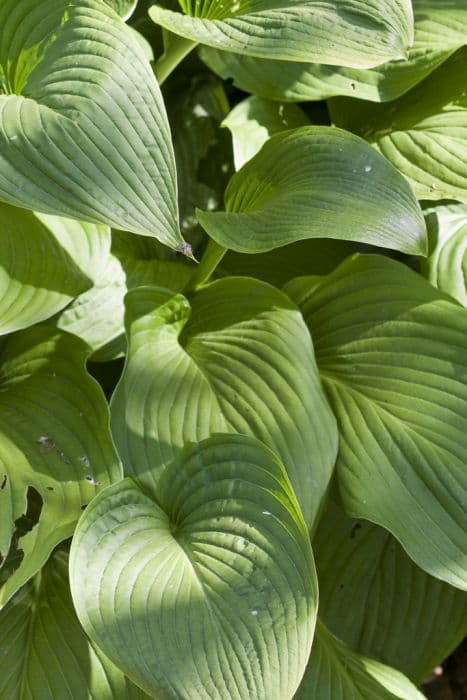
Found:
<box><xmin>200</xmin><ymin>0</ymin><xmax>467</xmax><ymax>102</ymax></box>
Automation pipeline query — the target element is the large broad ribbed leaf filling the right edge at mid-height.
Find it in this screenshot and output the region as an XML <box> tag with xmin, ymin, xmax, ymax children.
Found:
<box><xmin>287</xmin><ymin>255</ymin><xmax>467</xmax><ymax>588</ymax></box>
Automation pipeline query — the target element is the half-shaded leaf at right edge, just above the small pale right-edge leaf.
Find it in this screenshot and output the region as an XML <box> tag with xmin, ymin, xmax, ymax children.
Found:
<box><xmin>330</xmin><ymin>48</ymin><xmax>467</xmax><ymax>202</ymax></box>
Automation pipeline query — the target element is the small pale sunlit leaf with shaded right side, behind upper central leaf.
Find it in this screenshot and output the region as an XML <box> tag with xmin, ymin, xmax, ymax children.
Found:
<box><xmin>223</xmin><ymin>96</ymin><xmax>309</xmax><ymax>170</ymax></box>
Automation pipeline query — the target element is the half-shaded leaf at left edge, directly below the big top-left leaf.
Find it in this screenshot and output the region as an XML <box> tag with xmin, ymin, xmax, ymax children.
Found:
<box><xmin>0</xmin><ymin>204</ymin><xmax>110</xmax><ymax>335</ymax></box>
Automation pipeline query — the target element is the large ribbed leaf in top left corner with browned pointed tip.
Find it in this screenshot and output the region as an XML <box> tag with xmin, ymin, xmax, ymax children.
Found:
<box><xmin>0</xmin><ymin>0</ymin><xmax>186</xmax><ymax>248</ymax></box>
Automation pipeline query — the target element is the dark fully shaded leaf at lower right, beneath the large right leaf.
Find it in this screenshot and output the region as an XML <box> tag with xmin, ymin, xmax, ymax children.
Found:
<box><xmin>313</xmin><ymin>501</ymin><xmax>467</xmax><ymax>685</ymax></box>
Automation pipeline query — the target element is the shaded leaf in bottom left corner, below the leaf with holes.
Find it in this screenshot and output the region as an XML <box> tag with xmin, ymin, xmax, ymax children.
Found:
<box><xmin>0</xmin><ymin>552</ymin><xmax>149</xmax><ymax>700</ymax></box>
